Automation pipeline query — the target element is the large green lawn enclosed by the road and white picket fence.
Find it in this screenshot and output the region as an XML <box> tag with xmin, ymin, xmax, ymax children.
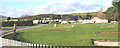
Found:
<box><xmin>5</xmin><ymin>23</ymin><xmax>118</xmax><ymax>46</ymax></box>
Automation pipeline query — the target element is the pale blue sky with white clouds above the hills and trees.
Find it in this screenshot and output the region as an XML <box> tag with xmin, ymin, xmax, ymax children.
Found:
<box><xmin>0</xmin><ymin>0</ymin><xmax>112</xmax><ymax>17</ymax></box>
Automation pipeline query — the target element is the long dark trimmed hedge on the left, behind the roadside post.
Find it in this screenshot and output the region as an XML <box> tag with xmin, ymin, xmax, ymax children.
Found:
<box><xmin>2</xmin><ymin>21</ymin><xmax>33</xmax><ymax>27</ymax></box>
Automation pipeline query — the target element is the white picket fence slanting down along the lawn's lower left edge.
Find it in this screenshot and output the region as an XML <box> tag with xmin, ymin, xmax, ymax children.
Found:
<box><xmin>0</xmin><ymin>38</ymin><xmax>70</xmax><ymax>48</ymax></box>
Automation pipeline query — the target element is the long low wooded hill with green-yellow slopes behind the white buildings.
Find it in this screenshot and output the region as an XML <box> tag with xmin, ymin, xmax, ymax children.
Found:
<box><xmin>16</xmin><ymin>12</ymin><xmax>97</xmax><ymax>20</ymax></box>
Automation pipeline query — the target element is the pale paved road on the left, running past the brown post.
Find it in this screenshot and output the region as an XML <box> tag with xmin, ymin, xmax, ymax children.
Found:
<box><xmin>0</xmin><ymin>24</ymin><xmax>48</xmax><ymax>37</ymax></box>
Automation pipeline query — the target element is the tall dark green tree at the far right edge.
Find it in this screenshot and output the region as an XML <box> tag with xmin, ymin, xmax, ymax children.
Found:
<box><xmin>105</xmin><ymin>1</ymin><xmax>120</xmax><ymax>21</ymax></box>
